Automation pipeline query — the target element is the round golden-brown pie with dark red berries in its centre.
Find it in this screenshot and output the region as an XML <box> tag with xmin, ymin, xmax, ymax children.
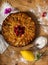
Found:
<box><xmin>2</xmin><ymin>12</ymin><xmax>36</xmax><ymax>47</ymax></box>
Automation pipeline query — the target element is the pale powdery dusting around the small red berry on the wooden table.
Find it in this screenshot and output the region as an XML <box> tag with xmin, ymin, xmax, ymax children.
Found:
<box><xmin>30</xmin><ymin>4</ymin><xmax>48</xmax><ymax>25</ymax></box>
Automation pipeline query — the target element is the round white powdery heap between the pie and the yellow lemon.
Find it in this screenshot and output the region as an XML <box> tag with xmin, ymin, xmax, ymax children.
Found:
<box><xmin>35</xmin><ymin>36</ymin><xmax>47</xmax><ymax>49</ymax></box>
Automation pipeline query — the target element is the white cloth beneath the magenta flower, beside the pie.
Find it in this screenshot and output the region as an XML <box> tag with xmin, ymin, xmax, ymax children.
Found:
<box><xmin>0</xmin><ymin>2</ymin><xmax>12</xmax><ymax>24</ymax></box>
